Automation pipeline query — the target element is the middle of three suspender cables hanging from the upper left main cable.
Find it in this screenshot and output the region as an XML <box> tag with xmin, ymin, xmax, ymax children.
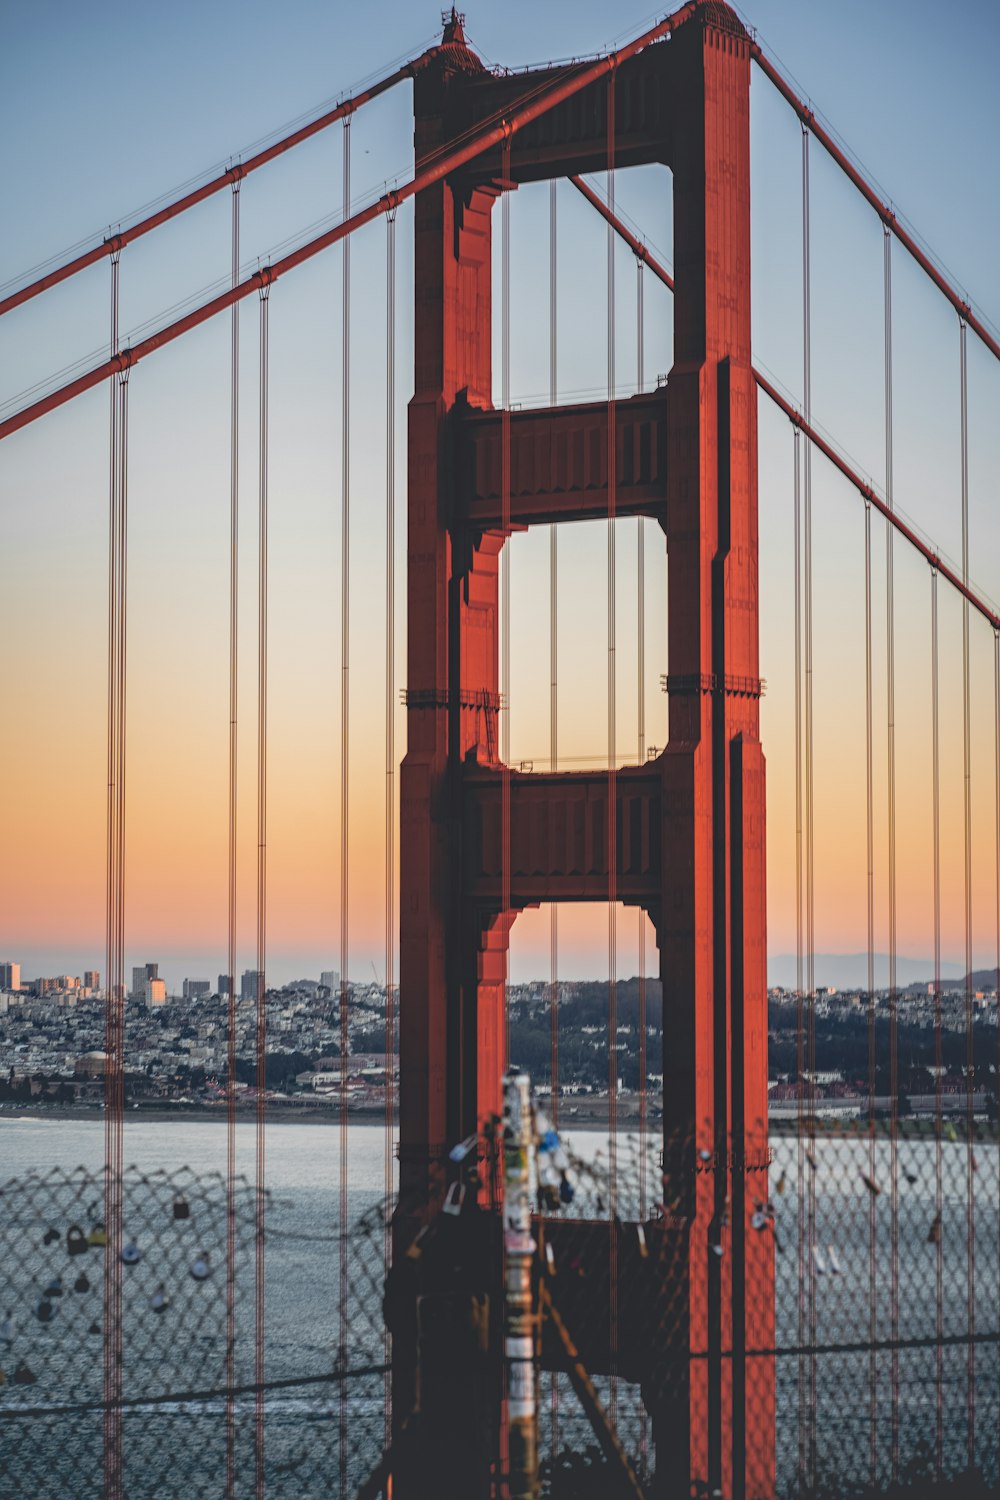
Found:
<box><xmin>226</xmin><ymin>177</ymin><xmax>241</xmax><ymax>1500</ymax></box>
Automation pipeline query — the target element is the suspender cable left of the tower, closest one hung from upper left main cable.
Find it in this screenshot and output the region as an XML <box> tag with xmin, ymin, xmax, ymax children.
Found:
<box><xmin>337</xmin><ymin>116</ymin><xmax>351</xmax><ymax>1497</ymax></box>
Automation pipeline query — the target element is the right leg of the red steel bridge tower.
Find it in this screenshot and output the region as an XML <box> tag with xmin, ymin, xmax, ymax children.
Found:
<box><xmin>665</xmin><ymin>17</ymin><xmax>774</xmax><ymax>1494</ymax></box>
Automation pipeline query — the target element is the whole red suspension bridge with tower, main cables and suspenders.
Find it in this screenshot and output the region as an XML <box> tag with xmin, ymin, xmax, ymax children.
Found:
<box><xmin>0</xmin><ymin>0</ymin><xmax>1000</xmax><ymax>1497</ymax></box>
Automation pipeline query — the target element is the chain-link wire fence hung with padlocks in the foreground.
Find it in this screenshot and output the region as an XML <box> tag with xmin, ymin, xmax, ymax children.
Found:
<box><xmin>0</xmin><ymin>1121</ymin><xmax>1000</xmax><ymax>1500</ymax></box>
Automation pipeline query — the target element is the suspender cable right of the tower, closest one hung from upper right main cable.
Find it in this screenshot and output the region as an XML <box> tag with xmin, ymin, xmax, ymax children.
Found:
<box><xmin>802</xmin><ymin>126</ymin><xmax>817</xmax><ymax>1479</ymax></box>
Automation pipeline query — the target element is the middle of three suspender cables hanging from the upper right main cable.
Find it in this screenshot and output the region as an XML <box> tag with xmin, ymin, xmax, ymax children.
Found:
<box><xmin>883</xmin><ymin>225</ymin><xmax>900</xmax><ymax>1481</ymax></box>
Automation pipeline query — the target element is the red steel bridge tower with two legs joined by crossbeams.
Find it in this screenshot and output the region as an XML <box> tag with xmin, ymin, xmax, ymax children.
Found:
<box><xmin>397</xmin><ymin>3</ymin><xmax>774</xmax><ymax>1496</ymax></box>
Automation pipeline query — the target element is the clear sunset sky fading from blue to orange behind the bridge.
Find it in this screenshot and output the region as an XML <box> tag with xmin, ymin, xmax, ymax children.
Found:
<box><xmin>0</xmin><ymin>0</ymin><xmax>1000</xmax><ymax>981</ymax></box>
